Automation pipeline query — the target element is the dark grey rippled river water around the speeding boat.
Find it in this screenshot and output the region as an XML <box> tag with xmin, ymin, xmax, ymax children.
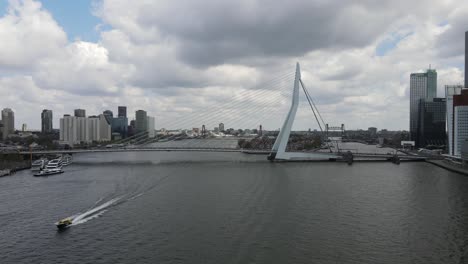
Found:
<box><xmin>0</xmin><ymin>152</ymin><xmax>468</xmax><ymax>264</ymax></box>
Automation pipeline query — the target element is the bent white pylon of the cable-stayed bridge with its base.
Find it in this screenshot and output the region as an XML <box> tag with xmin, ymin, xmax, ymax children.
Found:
<box><xmin>268</xmin><ymin>63</ymin><xmax>339</xmax><ymax>161</ymax></box>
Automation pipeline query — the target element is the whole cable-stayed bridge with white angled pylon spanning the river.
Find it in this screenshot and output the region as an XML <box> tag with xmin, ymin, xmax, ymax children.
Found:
<box><xmin>19</xmin><ymin>63</ymin><xmax>421</xmax><ymax>163</ymax></box>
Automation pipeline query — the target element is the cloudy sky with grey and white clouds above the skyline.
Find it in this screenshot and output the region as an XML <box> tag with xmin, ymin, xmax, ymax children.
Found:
<box><xmin>0</xmin><ymin>0</ymin><xmax>468</xmax><ymax>130</ymax></box>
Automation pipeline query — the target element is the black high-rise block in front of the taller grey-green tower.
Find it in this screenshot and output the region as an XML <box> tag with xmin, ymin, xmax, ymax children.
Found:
<box><xmin>416</xmin><ymin>98</ymin><xmax>447</xmax><ymax>147</ymax></box>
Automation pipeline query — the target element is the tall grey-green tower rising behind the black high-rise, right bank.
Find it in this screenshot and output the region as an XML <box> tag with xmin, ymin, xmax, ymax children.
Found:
<box><xmin>410</xmin><ymin>69</ymin><xmax>437</xmax><ymax>147</ymax></box>
